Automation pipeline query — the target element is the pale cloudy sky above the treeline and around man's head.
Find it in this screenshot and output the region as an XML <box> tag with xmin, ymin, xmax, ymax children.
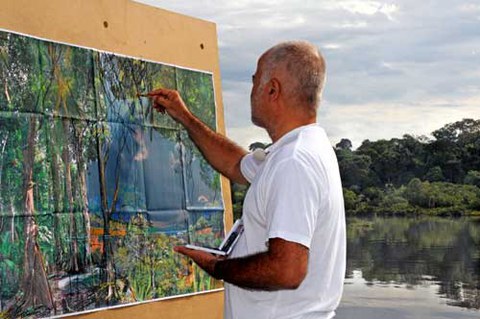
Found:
<box><xmin>137</xmin><ymin>0</ymin><xmax>480</xmax><ymax>148</ymax></box>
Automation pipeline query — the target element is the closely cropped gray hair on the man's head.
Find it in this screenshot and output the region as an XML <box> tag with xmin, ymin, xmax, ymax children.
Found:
<box><xmin>261</xmin><ymin>41</ymin><xmax>325</xmax><ymax>111</ymax></box>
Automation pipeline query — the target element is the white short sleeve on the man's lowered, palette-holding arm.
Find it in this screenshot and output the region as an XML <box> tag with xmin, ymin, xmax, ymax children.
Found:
<box><xmin>265</xmin><ymin>158</ymin><xmax>320</xmax><ymax>248</ymax></box>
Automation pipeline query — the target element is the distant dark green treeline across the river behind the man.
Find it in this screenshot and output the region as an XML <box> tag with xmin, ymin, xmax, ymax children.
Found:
<box><xmin>232</xmin><ymin>119</ymin><xmax>480</xmax><ymax>219</ymax></box>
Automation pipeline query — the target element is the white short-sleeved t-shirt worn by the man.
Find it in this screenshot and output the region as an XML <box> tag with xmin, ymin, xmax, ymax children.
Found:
<box><xmin>225</xmin><ymin>124</ymin><xmax>346</xmax><ymax>319</ymax></box>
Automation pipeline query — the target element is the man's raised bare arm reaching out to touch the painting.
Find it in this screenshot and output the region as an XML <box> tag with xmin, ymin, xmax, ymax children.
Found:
<box><xmin>148</xmin><ymin>89</ymin><xmax>248</xmax><ymax>184</ymax></box>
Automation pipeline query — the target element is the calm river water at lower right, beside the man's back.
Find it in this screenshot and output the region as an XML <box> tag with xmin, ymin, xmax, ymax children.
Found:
<box><xmin>335</xmin><ymin>217</ymin><xmax>480</xmax><ymax>319</ymax></box>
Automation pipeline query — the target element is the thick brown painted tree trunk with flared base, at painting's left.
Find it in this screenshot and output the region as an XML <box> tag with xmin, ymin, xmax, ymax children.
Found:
<box><xmin>7</xmin><ymin>117</ymin><xmax>54</xmax><ymax>317</ymax></box>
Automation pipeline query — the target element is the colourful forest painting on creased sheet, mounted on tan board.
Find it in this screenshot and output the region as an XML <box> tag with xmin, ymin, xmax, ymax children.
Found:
<box><xmin>0</xmin><ymin>32</ymin><xmax>224</xmax><ymax>318</ymax></box>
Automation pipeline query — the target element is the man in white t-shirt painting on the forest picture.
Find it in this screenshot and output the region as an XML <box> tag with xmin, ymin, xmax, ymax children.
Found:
<box><xmin>149</xmin><ymin>41</ymin><xmax>346</xmax><ymax>319</ymax></box>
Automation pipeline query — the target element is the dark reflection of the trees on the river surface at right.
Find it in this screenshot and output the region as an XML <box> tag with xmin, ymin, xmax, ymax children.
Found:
<box><xmin>347</xmin><ymin>217</ymin><xmax>480</xmax><ymax>309</ymax></box>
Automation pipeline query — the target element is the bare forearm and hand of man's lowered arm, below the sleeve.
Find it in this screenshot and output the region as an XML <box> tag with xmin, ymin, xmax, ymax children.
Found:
<box><xmin>175</xmin><ymin>238</ymin><xmax>309</xmax><ymax>290</ymax></box>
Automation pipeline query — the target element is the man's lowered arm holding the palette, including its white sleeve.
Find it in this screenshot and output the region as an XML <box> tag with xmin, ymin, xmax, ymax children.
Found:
<box><xmin>176</xmin><ymin>158</ymin><xmax>320</xmax><ymax>290</ymax></box>
